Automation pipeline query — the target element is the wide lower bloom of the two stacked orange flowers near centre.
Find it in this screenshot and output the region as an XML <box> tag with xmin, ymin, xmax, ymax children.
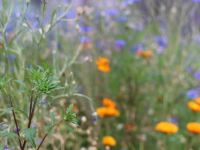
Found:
<box><xmin>96</xmin><ymin>107</ymin><xmax>120</xmax><ymax>117</ymax></box>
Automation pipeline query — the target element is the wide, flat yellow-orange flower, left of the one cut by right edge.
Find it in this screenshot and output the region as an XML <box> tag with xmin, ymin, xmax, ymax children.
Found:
<box><xmin>155</xmin><ymin>121</ymin><xmax>179</xmax><ymax>134</ymax></box>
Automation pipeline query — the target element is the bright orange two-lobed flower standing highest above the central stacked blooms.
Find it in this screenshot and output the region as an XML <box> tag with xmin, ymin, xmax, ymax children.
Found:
<box><xmin>96</xmin><ymin>57</ymin><xmax>110</xmax><ymax>73</ymax></box>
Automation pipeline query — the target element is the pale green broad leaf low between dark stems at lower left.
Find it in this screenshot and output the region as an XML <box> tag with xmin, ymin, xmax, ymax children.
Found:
<box><xmin>24</xmin><ymin>128</ymin><xmax>36</xmax><ymax>147</ymax></box>
